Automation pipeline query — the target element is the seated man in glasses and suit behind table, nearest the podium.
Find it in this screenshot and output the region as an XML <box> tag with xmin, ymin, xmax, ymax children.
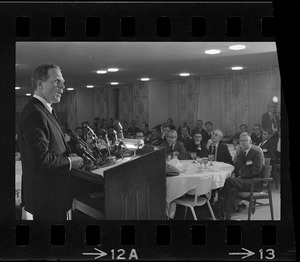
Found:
<box><xmin>160</xmin><ymin>129</ymin><xmax>188</xmax><ymax>160</ymax></box>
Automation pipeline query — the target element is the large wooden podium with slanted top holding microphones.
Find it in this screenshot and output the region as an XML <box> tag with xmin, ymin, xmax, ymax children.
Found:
<box><xmin>72</xmin><ymin>149</ymin><xmax>166</xmax><ymax>220</ymax></box>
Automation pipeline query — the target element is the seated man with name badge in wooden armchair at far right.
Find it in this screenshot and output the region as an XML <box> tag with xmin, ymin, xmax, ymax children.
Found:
<box><xmin>214</xmin><ymin>135</ymin><xmax>264</xmax><ymax>220</ymax></box>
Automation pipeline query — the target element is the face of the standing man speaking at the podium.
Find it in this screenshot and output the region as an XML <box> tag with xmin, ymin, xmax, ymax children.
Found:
<box><xmin>37</xmin><ymin>68</ymin><xmax>65</xmax><ymax>103</ymax></box>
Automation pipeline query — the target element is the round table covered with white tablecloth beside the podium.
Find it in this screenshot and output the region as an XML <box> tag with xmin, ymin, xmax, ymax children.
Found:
<box><xmin>166</xmin><ymin>160</ymin><xmax>234</xmax><ymax>218</ymax></box>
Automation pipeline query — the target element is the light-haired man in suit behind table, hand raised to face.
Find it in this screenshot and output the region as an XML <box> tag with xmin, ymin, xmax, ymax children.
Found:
<box><xmin>206</xmin><ymin>129</ymin><xmax>233</xmax><ymax>165</ymax></box>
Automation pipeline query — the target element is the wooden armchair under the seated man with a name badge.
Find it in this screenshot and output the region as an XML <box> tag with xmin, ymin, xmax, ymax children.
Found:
<box><xmin>237</xmin><ymin>165</ymin><xmax>274</xmax><ymax>220</ymax></box>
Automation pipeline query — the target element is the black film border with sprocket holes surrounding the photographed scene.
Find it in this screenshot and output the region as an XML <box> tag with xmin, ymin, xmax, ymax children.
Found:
<box><xmin>0</xmin><ymin>2</ymin><xmax>297</xmax><ymax>260</ymax></box>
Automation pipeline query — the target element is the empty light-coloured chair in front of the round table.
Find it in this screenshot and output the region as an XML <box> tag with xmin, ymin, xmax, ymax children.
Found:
<box><xmin>174</xmin><ymin>176</ymin><xmax>216</xmax><ymax>220</ymax></box>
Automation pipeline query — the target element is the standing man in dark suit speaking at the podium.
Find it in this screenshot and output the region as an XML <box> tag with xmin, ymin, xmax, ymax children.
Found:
<box><xmin>19</xmin><ymin>64</ymin><xmax>83</xmax><ymax>220</ymax></box>
